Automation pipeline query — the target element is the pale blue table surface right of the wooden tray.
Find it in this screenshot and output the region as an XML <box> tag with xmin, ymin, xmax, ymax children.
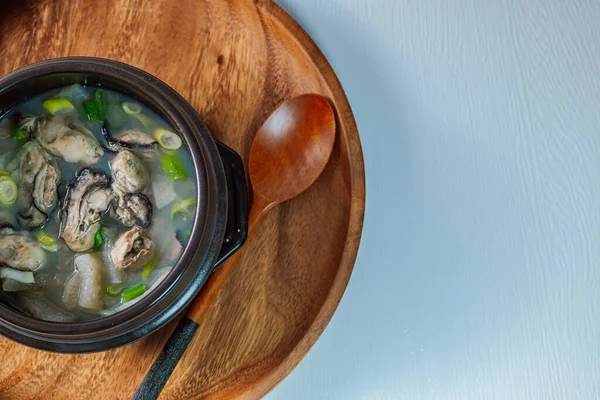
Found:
<box><xmin>267</xmin><ymin>0</ymin><xmax>600</xmax><ymax>400</ymax></box>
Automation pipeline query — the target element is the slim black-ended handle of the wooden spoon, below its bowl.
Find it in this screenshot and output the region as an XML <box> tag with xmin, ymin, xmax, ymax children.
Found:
<box><xmin>132</xmin><ymin>194</ymin><xmax>275</xmax><ymax>400</ymax></box>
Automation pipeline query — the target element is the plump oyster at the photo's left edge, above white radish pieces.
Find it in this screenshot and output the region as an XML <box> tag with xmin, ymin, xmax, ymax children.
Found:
<box><xmin>0</xmin><ymin>234</ymin><xmax>47</xmax><ymax>272</ymax></box>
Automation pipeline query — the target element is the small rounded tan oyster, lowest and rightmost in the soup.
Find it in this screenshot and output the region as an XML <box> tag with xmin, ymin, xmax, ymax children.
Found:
<box><xmin>111</xmin><ymin>226</ymin><xmax>156</xmax><ymax>271</ymax></box>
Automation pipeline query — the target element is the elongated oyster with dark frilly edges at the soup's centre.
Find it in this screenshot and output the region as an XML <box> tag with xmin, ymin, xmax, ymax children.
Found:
<box><xmin>60</xmin><ymin>168</ymin><xmax>113</xmax><ymax>252</ymax></box>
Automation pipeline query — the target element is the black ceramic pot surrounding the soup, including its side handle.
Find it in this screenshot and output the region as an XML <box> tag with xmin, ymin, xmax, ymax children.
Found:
<box><xmin>0</xmin><ymin>57</ymin><xmax>248</xmax><ymax>353</ymax></box>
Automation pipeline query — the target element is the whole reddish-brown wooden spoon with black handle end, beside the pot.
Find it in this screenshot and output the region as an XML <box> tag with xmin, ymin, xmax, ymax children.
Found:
<box><xmin>133</xmin><ymin>94</ymin><xmax>335</xmax><ymax>400</ymax></box>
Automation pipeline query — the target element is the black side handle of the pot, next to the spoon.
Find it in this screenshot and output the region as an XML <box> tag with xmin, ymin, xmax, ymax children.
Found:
<box><xmin>213</xmin><ymin>142</ymin><xmax>248</xmax><ymax>272</ymax></box>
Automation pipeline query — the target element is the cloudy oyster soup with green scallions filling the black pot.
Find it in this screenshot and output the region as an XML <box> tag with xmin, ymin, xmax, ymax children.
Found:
<box><xmin>0</xmin><ymin>85</ymin><xmax>197</xmax><ymax>322</ymax></box>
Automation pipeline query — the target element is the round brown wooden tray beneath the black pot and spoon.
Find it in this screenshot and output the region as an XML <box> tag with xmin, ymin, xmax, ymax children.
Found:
<box><xmin>0</xmin><ymin>0</ymin><xmax>365</xmax><ymax>400</ymax></box>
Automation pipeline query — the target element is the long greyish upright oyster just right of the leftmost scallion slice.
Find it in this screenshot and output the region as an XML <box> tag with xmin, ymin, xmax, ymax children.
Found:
<box><xmin>18</xmin><ymin>140</ymin><xmax>60</xmax><ymax>230</ymax></box>
